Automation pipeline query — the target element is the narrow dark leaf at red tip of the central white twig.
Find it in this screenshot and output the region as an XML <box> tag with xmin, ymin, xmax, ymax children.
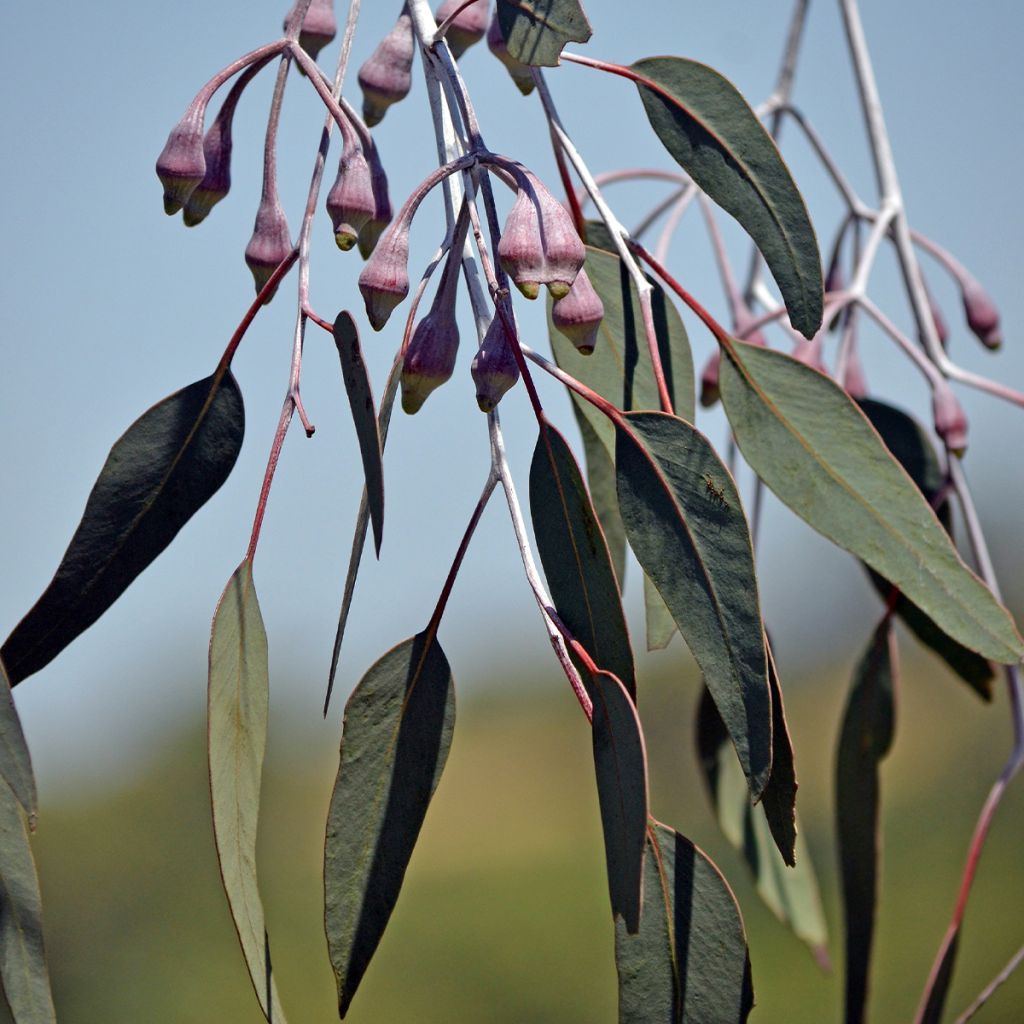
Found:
<box><xmin>583</xmin><ymin>672</ymin><xmax>648</xmax><ymax>935</ymax></box>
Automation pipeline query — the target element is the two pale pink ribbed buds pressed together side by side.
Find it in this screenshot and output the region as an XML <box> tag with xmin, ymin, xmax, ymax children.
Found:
<box><xmin>498</xmin><ymin>174</ymin><xmax>587</xmax><ymax>299</ymax></box>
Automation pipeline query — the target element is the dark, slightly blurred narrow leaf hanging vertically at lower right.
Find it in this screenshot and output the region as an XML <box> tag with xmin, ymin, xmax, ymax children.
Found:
<box><xmin>836</xmin><ymin>620</ymin><xmax>897</xmax><ymax>1024</ymax></box>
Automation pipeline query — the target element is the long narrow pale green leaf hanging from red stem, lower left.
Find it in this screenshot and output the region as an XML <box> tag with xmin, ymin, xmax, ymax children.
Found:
<box><xmin>209</xmin><ymin>559</ymin><xmax>285</xmax><ymax>1024</ymax></box>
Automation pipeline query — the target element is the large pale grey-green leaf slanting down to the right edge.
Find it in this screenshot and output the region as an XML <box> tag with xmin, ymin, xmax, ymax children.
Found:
<box><xmin>720</xmin><ymin>341</ymin><xmax>1024</xmax><ymax>663</ymax></box>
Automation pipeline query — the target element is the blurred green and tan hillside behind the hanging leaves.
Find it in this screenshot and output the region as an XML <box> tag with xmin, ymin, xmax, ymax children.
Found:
<box><xmin>8</xmin><ymin>637</ymin><xmax>1024</xmax><ymax>1024</ymax></box>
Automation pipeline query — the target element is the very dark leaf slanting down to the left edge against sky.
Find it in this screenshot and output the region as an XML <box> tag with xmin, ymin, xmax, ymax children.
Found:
<box><xmin>0</xmin><ymin>370</ymin><xmax>245</xmax><ymax>685</ymax></box>
